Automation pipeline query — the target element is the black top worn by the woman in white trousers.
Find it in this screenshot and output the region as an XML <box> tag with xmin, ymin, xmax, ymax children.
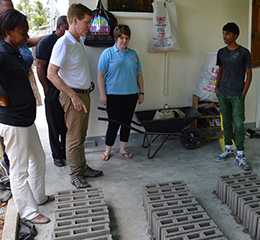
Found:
<box><xmin>0</xmin><ymin>40</ymin><xmax>36</xmax><ymax>127</ymax></box>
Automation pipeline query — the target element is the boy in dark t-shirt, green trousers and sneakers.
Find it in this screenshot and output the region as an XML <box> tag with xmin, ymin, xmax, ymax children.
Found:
<box><xmin>215</xmin><ymin>23</ymin><xmax>252</xmax><ymax>170</ymax></box>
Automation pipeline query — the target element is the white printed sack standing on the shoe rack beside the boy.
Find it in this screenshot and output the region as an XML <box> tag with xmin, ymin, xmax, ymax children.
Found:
<box><xmin>194</xmin><ymin>52</ymin><xmax>219</xmax><ymax>102</ymax></box>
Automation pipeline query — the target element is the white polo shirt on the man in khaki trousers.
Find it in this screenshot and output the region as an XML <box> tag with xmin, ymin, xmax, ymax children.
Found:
<box><xmin>50</xmin><ymin>31</ymin><xmax>91</xmax><ymax>89</ymax></box>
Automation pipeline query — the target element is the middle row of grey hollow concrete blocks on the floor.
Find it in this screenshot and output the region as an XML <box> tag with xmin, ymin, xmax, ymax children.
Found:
<box><xmin>143</xmin><ymin>181</ymin><xmax>227</xmax><ymax>240</ymax></box>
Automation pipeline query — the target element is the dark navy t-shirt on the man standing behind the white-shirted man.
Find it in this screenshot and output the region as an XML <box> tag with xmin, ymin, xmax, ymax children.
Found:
<box><xmin>35</xmin><ymin>32</ymin><xmax>60</xmax><ymax>99</ymax></box>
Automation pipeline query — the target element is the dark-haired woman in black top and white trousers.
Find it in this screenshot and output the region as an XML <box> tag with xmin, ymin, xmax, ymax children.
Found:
<box><xmin>0</xmin><ymin>9</ymin><xmax>54</xmax><ymax>224</ymax></box>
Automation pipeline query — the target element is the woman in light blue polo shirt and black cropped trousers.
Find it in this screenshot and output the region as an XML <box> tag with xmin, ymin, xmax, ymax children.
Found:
<box><xmin>98</xmin><ymin>24</ymin><xmax>144</xmax><ymax>161</ymax></box>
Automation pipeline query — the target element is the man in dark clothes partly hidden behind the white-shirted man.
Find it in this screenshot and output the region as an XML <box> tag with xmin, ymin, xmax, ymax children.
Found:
<box><xmin>36</xmin><ymin>16</ymin><xmax>69</xmax><ymax>167</ymax></box>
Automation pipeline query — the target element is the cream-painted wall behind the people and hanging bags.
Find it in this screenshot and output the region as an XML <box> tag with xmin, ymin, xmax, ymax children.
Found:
<box><xmin>66</xmin><ymin>0</ymin><xmax>258</xmax><ymax>136</ymax></box>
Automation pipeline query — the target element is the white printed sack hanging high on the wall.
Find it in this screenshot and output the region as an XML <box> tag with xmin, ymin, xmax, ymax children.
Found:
<box><xmin>151</xmin><ymin>0</ymin><xmax>181</xmax><ymax>53</ymax></box>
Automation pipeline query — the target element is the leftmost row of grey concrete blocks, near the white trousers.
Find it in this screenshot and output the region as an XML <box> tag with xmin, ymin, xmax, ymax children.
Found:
<box><xmin>52</xmin><ymin>188</ymin><xmax>112</xmax><ymax>240</ymax></box>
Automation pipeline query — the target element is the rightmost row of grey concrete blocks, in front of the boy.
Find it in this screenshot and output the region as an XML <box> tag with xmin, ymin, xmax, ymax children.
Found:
<box><xmin>217</xmin><ymin>172</ymin><xmax>260</xmax><ymax>240</ymax></box>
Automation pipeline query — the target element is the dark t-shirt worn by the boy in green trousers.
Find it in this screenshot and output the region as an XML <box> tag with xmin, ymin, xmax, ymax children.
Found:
<box><xmin>217</xmin><ymin>46</ymin><xmax>252</xmax><ymax>96</ymax></box>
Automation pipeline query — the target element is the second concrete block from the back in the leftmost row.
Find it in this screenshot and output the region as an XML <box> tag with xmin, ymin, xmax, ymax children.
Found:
<box><xmin>55</xmin><ymin>192</ymin><xmax>104</xmax><ymax>204</ymax></box>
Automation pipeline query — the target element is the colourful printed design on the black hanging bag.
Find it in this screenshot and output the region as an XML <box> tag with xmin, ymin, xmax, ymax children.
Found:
<box><xmin>90</xmin><ymin>16</ymin><xmax>110</xmax><ymax>35</ymax></box>
